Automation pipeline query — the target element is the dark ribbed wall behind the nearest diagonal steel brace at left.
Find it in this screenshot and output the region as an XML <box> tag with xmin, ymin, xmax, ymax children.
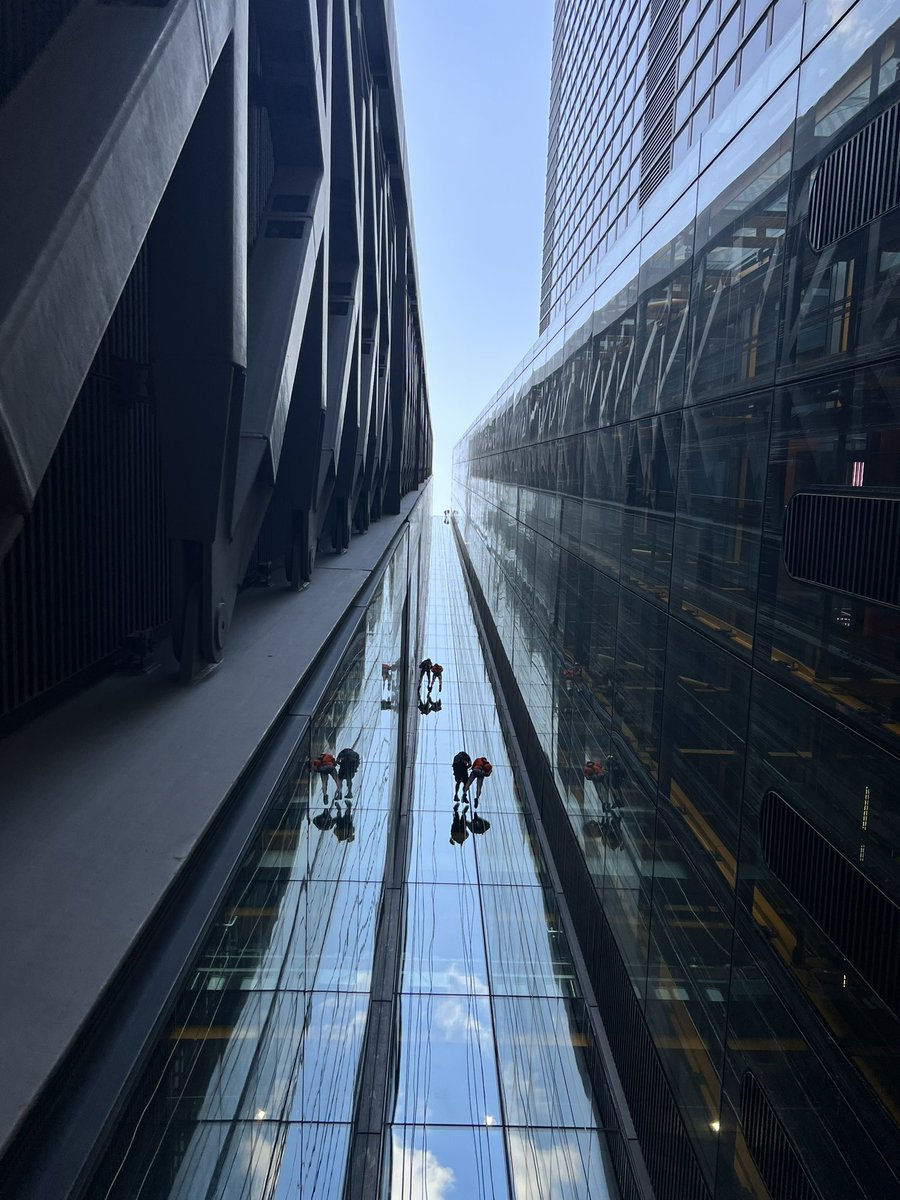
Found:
<box><xmin>0</xmin><ymin>243</ymin><xmax>169</xmax><ymax>728</ymax></box>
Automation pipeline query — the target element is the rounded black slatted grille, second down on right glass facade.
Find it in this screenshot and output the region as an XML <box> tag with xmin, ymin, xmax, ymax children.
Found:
<box><xmin>782</xmin><ymin>490</ymin><xmax>900</xmax><ymax>606</ymax></box>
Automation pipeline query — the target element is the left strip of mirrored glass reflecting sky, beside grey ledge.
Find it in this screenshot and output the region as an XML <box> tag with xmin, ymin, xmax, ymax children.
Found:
<box><xmin>92</xmin><ymin>554</ymin><xmax>406</xmax><ymax>1200</ymax></box>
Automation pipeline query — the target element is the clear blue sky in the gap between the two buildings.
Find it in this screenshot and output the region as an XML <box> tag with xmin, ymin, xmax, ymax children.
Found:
<box><xmin>394</xmin><ymin>0</ymin><xmax>553</xmax><ymax>511</ymax></box>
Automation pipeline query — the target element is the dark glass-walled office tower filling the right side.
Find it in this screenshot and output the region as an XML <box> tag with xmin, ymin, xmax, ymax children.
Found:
<box><xmin>454</xmin><ymin>0</ymin><xmax>900</xmax><ymax>1200</ymax></box>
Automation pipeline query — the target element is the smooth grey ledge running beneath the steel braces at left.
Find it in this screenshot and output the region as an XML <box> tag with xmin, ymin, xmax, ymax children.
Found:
<box><xmin>0</xmin><ymin>484</ymin><xmax>428</xmax><ymax>1150</ymax></box>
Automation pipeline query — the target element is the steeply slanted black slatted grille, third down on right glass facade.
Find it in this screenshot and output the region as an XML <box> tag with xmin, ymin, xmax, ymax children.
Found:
<box><xmin>760</xmin><ymin>792</ymin><xmax>900</xmax><ymax>1013</ymax></box>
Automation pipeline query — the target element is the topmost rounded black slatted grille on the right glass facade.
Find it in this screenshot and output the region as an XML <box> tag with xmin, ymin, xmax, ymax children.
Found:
<box><xmin>809</xmin><ymin>104</ymin><xmax>900</xmax><ymax>251</ymax></box>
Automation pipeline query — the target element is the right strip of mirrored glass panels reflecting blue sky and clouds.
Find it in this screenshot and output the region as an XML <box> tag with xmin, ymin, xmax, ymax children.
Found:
<box><xmin>384</xmin><ymin>526</ymin><xmax>608</xmax><ymax>1200</ymax></box>
